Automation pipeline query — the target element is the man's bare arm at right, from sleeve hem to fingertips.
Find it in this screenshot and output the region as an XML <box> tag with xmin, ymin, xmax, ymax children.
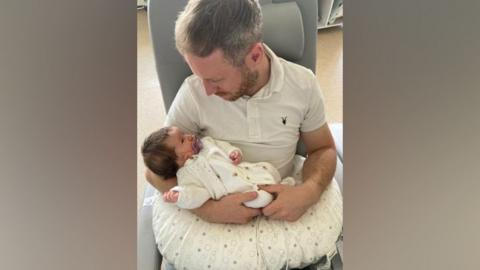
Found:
<box><xmin>262</xmin><ymin>124</ymin><xmax>337</xmax><ymax>221</ymax></box>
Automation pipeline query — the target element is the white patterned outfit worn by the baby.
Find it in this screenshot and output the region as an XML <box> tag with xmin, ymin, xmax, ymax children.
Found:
<box><xmin>173</xmin><ymin>137</ymin><xmax>294</xmax><ymax>209</ymax></box>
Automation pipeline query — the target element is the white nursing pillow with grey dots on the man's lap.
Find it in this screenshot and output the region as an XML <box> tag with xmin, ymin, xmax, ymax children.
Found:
<box><xmin>152</xmin><ymin>155</ymin><xmax>343</xmax><ymax>270</ymax></box>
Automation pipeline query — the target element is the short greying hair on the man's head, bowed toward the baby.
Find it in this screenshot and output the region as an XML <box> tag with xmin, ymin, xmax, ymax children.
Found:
<box><xmin>175</xmin><ymin>0</ymin><xmax>262</xmax><ymax>66</ymax></box>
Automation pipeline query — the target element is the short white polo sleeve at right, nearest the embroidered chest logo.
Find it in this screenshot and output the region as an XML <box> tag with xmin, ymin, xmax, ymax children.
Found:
<box><xmin>300</xmin><ymin>74</ymin><xmax>326</xmax><ymax>132</ymax></box>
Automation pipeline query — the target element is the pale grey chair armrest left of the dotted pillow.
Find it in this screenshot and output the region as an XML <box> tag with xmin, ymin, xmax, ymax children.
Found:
<box><xmin>137</xmin><ymin>183</ymin><xmax>162</xmax><ymax>270</ymax></box>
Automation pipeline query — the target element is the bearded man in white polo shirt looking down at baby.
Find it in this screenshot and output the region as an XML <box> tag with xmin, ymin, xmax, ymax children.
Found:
<box><xmin>146</xmin><ymin>0</ymin><xmax>336</xmax><ymax>223</ymax></box>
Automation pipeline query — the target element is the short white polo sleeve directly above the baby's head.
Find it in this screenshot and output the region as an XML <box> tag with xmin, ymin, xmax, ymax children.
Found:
<box><xmin>164</xmin><ymin>78</ymin><xmax>200</xmax><ymax>134</ymax></box>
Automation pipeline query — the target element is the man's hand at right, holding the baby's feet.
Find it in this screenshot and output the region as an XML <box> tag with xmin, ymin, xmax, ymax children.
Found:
<box><xmin>259</xmin><ymin>182</ymin><xmax>322</xmax><ymax>222</ymax></box>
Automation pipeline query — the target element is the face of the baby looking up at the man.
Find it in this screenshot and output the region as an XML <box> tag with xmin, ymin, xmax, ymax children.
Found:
<box><xmin>165</xmin><ymin>127</ymin><xmax>200</xmax><ymax>166</ymax></box>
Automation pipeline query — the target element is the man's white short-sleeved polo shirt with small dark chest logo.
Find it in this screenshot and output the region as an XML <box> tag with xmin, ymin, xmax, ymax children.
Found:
<box><xmin>165</xmin><ymin>44</ymin><xmax>326</xmax><ymax>178</ymax></box>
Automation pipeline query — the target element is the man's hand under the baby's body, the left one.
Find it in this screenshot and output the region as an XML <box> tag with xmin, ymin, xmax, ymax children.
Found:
<box><xmin>192</xmin><ymin>191</ymin><xmax>261</xmax><ymax>224</ymax></box>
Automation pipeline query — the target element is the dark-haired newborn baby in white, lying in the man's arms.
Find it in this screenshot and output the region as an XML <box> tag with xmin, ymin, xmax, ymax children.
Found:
<box><xmin>142</xmin><ymin>127</ymin><xmax>295</xmax><ymax>209</ymax></box>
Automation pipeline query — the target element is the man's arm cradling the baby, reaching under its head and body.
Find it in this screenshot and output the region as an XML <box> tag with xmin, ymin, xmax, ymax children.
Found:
<box><xmin>145</xmin><ymin>169</ymin><xmax>261</xmax><ymax>224</ymax></box>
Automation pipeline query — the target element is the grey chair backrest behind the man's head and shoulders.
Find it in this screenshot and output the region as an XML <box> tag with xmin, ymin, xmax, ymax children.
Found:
<box><xmin>148</xmin><ymin>0</ymin><xmax>318</xmax><ymax>154</ymax></box>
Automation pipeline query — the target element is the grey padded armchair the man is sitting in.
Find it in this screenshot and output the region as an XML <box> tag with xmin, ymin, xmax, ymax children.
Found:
<box><xmin>137</xmin><ymin>0</ymin><xmax>343</xmax><ymax>270</ymax></box>
